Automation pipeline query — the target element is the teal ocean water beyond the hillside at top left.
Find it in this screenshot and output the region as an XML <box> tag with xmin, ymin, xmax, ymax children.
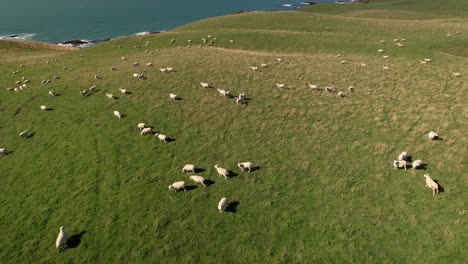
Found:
<box><xmin>0</xmin><ymin>0</ymin><xmax>332</xmax><ymax>43</ymax></box>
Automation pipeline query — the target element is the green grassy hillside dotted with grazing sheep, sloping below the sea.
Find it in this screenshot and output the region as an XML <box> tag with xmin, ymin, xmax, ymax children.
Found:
<box><xmin>0</xmin><ymin>0</ymin><xmax>468</xmax><ymax>263</ymax></box>
